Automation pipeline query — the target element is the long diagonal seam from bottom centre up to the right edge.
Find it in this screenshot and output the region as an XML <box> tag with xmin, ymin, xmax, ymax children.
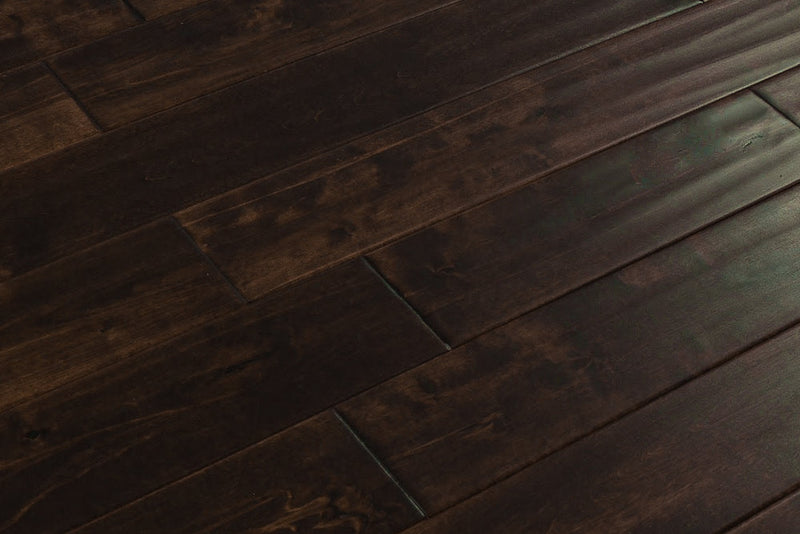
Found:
<box><xmin>400</xmin><ymin>317</ymin><xmax>800</xmax><ymax>526</ymax></box>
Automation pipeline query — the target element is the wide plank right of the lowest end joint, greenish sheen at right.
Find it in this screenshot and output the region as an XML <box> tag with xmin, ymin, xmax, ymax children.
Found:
<box><xmin>341</xmin><ymin>183</ymin><xmax>800</xmax><ymax>512</ymax></box>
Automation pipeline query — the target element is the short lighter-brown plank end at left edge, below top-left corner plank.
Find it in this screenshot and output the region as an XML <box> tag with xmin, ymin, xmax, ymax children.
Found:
<box><xmin>0</xmin><ymin>64</ymin><xmax>97</xmax><ymax>174</ymax></box>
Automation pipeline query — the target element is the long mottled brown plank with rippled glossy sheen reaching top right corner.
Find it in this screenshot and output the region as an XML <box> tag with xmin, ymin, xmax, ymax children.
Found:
<box><xmin>179</xmin><ymin>0</ymin><xmax>800</xmax><ymax>298</ymax></box>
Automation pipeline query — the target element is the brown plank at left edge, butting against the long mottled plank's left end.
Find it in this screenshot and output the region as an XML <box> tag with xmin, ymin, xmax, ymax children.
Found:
<box><xmin>0</xmin><ymin>221</ymin><xmax>239</xmax><ymax>409</ymax></box>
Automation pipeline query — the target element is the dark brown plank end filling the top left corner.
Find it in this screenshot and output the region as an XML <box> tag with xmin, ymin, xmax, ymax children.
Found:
<box><xmin>0</xmin><ymin>0</ymin><xmax>138</xmax><ymax>72</ymax></box>
